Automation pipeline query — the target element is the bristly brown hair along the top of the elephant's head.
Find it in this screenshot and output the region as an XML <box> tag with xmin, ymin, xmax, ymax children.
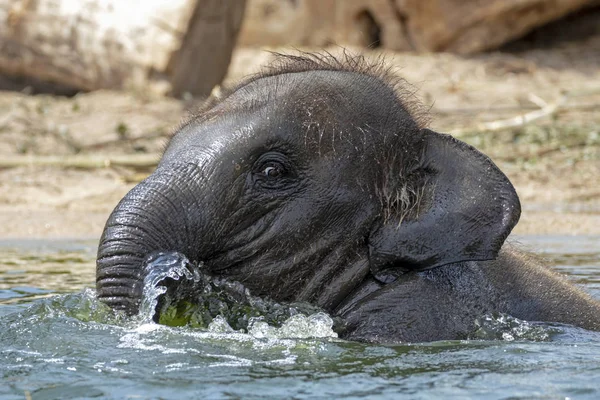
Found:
<box><xmin>182</xmin><ymin>50</ymin><xmax>429</xmax><ymax>128</ymax></box>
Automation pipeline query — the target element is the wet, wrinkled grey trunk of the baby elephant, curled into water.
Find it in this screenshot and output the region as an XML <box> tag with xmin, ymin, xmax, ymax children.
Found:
<box><xmin>96</xmin><ymin>169</ymin><xmax>202</xmax><ymax>315</ymax></box>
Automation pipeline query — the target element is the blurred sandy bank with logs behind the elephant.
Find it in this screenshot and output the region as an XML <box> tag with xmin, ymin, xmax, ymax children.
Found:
<box><xmin>0</xmin><ymin>0</ymin><xmax>600</xmax><ymax>238</ymax></box>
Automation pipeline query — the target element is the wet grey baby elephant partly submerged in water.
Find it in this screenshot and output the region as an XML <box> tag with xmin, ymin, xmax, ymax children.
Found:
<box><xmin>97</xmin><ymin>55</ymin><xmax>600</xmax><ymax>343</ymax></box>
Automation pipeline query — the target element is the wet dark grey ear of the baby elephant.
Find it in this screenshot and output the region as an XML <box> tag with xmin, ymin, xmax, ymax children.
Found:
<box><xmin>369</xmin><ymin>129</ymin><xmax>521</xmax><ymax>282</ymax></box>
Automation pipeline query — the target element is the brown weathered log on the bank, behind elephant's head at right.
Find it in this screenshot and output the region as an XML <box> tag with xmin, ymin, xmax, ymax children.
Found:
<box><xmin>240</xmin><ymin>0</ymin><xmax>599</xmax><ymax>53</ymax></box>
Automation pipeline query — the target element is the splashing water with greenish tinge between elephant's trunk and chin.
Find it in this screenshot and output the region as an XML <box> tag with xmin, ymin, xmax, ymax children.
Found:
<box><xmin>136</xmin><ymin>252</ymin><xmax>337</xmax><ymax>339</ymax></box>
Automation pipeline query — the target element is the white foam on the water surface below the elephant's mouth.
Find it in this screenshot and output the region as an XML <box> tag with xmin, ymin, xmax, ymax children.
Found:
<box><xmin>117</xmin><ymin>314</ymin><xmax>337</xmax><ymax>371</ymax></box>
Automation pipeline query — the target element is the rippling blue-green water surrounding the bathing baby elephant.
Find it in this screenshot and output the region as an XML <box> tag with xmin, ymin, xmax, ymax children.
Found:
<box><xmin>0</xmin><ymin>236</ymin><xmax>600</xmax><ymax>399</ymax></box>
